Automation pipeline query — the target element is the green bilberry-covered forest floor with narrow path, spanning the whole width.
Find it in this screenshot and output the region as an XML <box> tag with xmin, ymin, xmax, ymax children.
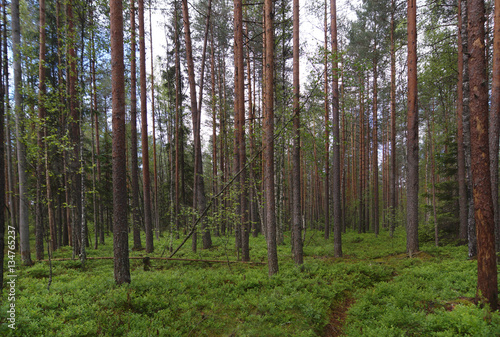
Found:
<box><xmin>0</xmin><ymin>230</ymin><xmax>500</xmax><ymax>337</ymax></box>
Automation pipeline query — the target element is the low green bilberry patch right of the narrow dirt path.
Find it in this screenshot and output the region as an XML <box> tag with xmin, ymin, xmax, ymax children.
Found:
<box><xmin>346</xmin><ymin>243</ymin><xmax>500</xmax><ymax>336</ymax></box>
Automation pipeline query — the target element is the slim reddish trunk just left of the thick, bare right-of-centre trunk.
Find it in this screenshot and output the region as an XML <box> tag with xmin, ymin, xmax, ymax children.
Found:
<box><xmin>389</xmin><ymin>0</ymin><xmax>396</xmax><ymax>237</ymax></box>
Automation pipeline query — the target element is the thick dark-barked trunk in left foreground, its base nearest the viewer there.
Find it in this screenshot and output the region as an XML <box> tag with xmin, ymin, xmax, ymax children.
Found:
<box><xmin>109</xmin><ymin>0</ymin><xmax>130</xmax><ymax>284</ymax></box>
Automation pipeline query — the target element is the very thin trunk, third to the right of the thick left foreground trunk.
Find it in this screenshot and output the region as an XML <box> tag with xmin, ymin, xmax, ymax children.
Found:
<box><xmin>149</xmin><ymin>6</ymin><xmax>160</xmax><ymax>240</ymax></box>
